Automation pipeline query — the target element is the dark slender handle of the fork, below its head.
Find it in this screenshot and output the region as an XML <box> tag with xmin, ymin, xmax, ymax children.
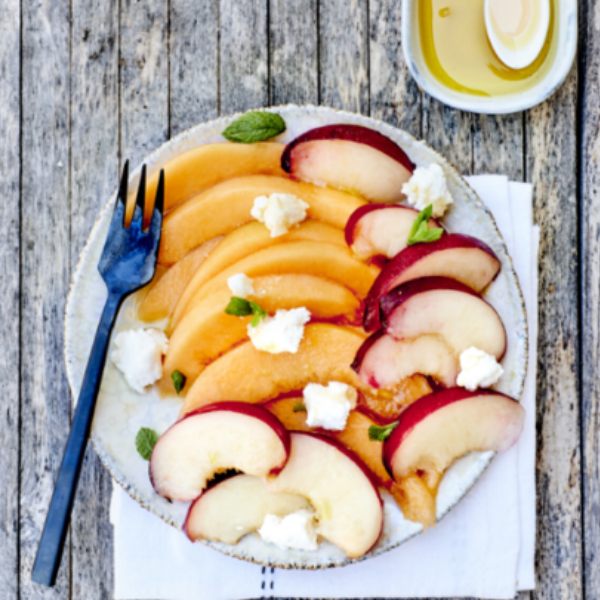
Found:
<box><xmin>31</xmin><ymin>294</ymin><xmax>124</xmax><ymax>587</ymax></box>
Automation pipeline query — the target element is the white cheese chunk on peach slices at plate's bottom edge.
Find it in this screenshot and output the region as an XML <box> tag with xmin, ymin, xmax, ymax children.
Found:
<box><xmin>258</xmin><ymin>509</ymin><xmax>319</xmax><ymax>550</ymax></box>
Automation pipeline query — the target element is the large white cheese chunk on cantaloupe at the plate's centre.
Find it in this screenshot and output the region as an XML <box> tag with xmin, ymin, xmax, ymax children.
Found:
<box><xmin>248</xmin><ymin>307</ymin><xmax>310</xmax><ymax>354</ymax></box>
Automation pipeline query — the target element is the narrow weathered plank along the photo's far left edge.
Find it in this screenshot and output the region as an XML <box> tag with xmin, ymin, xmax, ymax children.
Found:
<box><xmin>0</xmin><ymin>0</ymin><xmax>21</xmax><ymax>600</ymax></box>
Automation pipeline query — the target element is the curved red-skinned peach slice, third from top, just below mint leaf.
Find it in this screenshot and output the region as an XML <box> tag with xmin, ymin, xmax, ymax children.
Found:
<box><xmin>364</xmin><ymin>233</ymin><xmax>500</xmax><ymax>331</ymax></box>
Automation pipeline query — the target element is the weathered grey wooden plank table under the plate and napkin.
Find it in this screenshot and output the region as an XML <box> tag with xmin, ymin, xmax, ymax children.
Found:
<box><xmin>0</xmin><ymin>0</ymin><xmax>600</xmax><ymax>600</ymax></box>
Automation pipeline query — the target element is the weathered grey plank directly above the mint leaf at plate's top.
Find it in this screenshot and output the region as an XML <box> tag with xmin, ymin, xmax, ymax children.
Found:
<box><xmin>219</xmin><ymin>0</ymin><xmax>269</xmax><ymax>115</ymax></box>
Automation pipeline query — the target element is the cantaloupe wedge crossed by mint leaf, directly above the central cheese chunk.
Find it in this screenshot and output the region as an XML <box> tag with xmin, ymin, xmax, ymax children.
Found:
<box><xmin>163</xmin><ymin>273</ymin><xmax>362</xmax><ymax>385</ymax></box>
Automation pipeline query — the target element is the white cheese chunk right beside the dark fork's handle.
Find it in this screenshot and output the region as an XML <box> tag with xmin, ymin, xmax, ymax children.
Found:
<box><xmin>110</xmin><ymin>328</ymin><xmax>169</xmax><ymax>394</ymax></box>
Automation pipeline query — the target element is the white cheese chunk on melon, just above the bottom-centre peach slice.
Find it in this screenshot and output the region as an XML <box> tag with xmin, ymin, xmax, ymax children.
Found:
<box><xmin>302</xmin><ymin>381</ymin><xmax>358</xmax><ymax>431</ymax></box>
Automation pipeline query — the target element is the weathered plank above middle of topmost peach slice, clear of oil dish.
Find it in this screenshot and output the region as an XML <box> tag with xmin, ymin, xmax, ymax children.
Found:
<box><xmin>319</xmin><ymin>0</ymin><xmax>370</xmax><ymax>115</ymax></box>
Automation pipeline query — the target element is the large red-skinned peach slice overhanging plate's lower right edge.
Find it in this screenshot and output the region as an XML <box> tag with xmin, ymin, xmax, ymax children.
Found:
<box><xmin>383</xmin><ymin>388</ymin><xmax>525</xmax><ymax>480</ymax></box>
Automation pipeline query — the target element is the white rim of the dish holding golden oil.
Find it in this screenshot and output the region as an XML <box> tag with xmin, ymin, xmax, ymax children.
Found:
<box><xmin>402</xmin><ymin>0</ymin><xmax>577</xmax><ymax>115</ymax></box>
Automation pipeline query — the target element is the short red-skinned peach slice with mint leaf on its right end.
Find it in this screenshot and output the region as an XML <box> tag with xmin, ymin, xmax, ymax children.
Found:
<box><xmin>345</xmin><ymin>204</ymin><xmax>441</xmax><ymax>260</ymax></box>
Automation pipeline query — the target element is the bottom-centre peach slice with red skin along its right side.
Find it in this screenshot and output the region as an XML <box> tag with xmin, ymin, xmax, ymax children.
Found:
<box><xmin>267</xmin><ymin>431</ymin><xmax>383</xmax><ymax>558</ymax></box>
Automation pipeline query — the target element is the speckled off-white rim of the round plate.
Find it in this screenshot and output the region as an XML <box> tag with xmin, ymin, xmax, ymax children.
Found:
<box><xmin>64</xmin><ymin>104</ymin><xmax>528</xmax><ymax>569</ymax></box>
